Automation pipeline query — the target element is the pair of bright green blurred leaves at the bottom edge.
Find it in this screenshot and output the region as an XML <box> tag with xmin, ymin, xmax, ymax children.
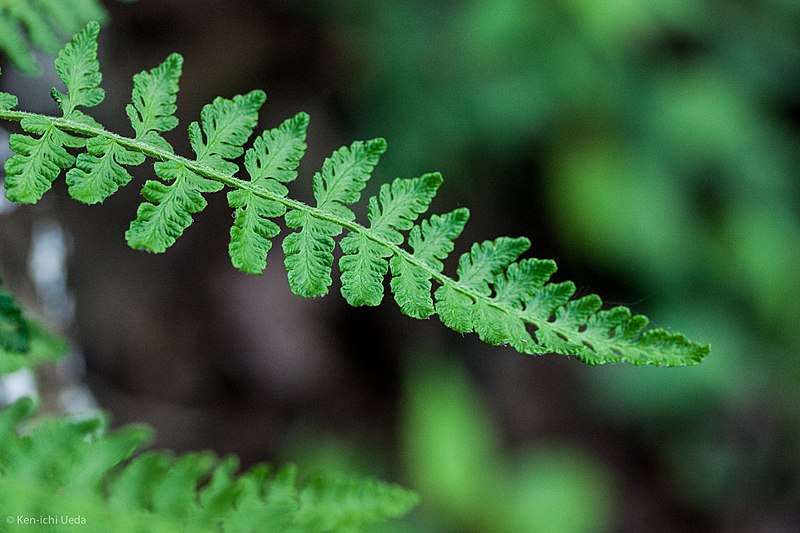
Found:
<box><xmin>403</xmin><ymin>358</ymin><xmax>616</xmax><ymax>533</ymax></box>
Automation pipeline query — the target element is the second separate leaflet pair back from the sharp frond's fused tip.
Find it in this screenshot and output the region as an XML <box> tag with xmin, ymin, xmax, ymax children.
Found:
<box><xmin>339</xmin><ymin>174</ymin><xmax>442</xmax><ymax>306</ymax></box>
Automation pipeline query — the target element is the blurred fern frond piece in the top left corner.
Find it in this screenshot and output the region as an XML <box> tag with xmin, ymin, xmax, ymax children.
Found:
<box><xmin>0</xmin><ymin>0</ymin><xmax>106</xmax><ymax>73</ymax></box>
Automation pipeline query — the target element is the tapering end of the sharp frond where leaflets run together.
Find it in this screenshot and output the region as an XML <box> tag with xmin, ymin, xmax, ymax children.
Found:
<box><xmin>436</xmin><ymin>249</ymin><xmax>708</xmax><ymax>366</ymax></box>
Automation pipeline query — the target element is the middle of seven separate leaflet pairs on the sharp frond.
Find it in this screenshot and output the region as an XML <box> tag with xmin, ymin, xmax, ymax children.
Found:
<box><xmin>228</xmin><ymin>113</ymin><xmax>309</xmax><ymax>274</ymax></box>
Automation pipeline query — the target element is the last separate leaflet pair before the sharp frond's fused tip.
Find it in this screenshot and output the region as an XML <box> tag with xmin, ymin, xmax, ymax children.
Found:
<box><xmin>391</xmin><ymin>207</ymin><xmax>469</xmax><ymax>318</ymax></box>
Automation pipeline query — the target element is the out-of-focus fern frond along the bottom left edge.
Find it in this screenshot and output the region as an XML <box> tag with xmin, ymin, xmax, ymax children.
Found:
<box><xmin>0</xmin><ymin>399</ymin><xmax>418</xmax><ymax>533</ymax></box>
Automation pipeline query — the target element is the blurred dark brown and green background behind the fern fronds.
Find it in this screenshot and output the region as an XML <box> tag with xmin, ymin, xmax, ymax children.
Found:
<box><xmin>0</xmin><ymin>0</ymin><xmax>800</xmax><ymax>533</ymax></box>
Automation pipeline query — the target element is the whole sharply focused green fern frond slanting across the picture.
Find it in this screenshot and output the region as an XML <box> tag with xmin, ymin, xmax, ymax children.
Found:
<box><xmin>0</xmin><ymin>25</ymin><xmax>708</xmax><ymax>365</ymax></box>
